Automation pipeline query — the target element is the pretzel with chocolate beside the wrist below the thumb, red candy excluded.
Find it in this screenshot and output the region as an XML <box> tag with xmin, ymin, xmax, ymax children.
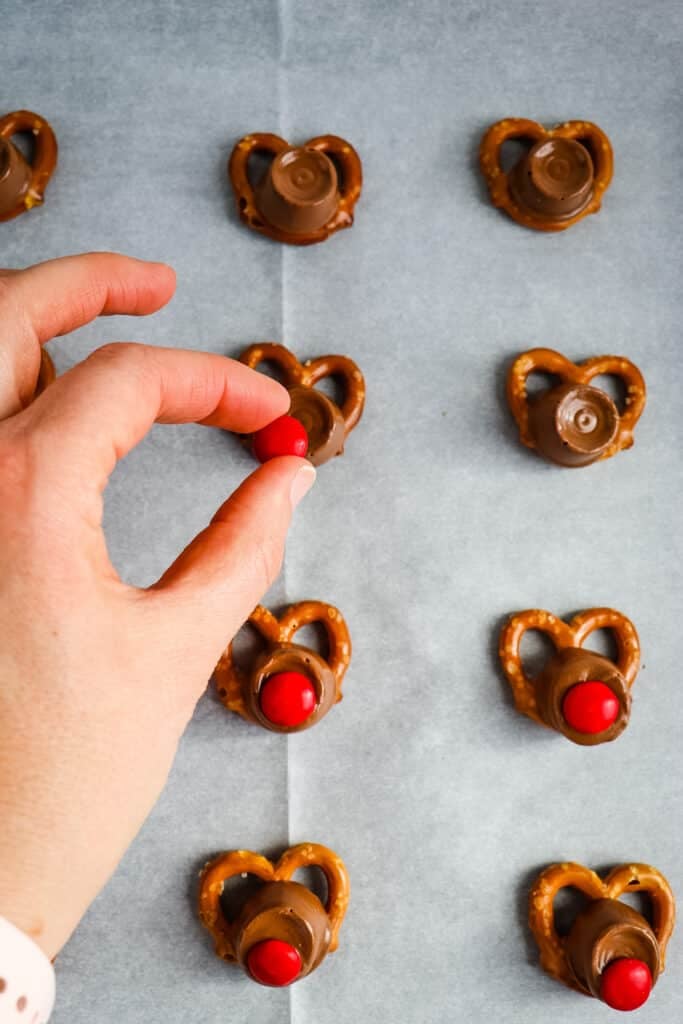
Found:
<box><xmin>214</xmin><ymin>601</ymin><xmax>351</xmax><ymax>732</ymax></box>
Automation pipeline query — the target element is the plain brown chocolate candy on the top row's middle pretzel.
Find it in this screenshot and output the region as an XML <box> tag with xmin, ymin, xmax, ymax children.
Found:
<box><xmin>255</xmin><ymin>146</ymin><xmax>339</xmax><ymax>234</ymax></box>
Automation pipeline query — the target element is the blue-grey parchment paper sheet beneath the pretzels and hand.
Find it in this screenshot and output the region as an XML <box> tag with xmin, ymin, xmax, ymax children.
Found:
<box><xmin>0</xmin><ymin>0</ymin><xmax>683</xmax><ymax>1024</ymax></box>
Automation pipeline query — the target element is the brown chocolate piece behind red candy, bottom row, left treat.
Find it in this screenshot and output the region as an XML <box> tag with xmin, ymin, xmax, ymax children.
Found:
<box><xmin>233</xmin><ymin>882</ymin><xmax>331</xmax><ymax>981</ymax></box>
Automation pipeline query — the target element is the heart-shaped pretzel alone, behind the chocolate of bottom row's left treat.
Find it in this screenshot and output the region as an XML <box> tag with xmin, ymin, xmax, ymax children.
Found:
<box><xmin>199</xmin><ymin>843</ymin><xmax>349</xmax><ymax>962</ymax></box>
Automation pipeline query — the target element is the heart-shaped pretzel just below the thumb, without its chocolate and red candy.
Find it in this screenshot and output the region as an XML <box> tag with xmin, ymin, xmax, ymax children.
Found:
<box><xmin>214</xmin><ymin>601</ymin><xmax>351</xmax><ymax>720</ymax></box>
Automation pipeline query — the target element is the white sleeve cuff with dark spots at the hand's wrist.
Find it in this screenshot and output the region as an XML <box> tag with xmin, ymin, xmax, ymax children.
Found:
<box><xmin>0</xmin><ymin>918</ymin><xmax>54</xmax><ymax>1024</ymax></box>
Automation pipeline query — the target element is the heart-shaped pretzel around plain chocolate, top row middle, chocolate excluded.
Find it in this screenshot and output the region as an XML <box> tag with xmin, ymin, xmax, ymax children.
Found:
<box><xmin>227</xmin><ymin>132</ymin><xmax>362</xmax><ymax>246</ymax></box>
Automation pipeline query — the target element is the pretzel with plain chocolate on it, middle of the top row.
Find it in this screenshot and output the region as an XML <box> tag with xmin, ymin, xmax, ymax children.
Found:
<box><xmin>227</xmin><ymin>132</ymin><xmax>362</xmax><ymax>246</ymax></box>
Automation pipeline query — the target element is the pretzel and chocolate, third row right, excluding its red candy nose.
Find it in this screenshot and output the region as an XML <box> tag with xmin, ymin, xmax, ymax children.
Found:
<box><xmin>499</xmin><ymin>608</ymin><xmax>640</xmax><ymax>746</ymax></box>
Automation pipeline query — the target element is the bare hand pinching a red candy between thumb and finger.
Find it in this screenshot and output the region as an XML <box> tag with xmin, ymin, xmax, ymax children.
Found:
<box><xmin>0</xmin><ymin>253</ymin><xmax>314</xmax><ymax>957</ymax></box>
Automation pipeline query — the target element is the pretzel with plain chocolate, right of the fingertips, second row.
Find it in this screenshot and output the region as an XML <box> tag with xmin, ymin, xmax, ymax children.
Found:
<box><xmin>507</xmin><ymin>348</ymin><xmax>646</xmax><ymax>465</ymax></box>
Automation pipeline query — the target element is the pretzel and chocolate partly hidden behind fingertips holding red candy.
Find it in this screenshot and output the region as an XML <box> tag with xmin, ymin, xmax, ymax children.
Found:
<box><xmin>240</xmin><ymin>342</ymin><xmax>366</xmax><ymax>466</ymax></box>
